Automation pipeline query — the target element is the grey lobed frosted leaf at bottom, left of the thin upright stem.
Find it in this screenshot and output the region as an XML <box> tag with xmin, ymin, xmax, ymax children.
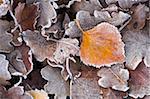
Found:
<box><xmin>41</xmin><ymin>66</ymin><xmax>70</xmax><ymax>99</ymax></box>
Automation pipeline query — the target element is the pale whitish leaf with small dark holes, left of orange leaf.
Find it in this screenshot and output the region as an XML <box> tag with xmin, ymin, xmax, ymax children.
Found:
<box><xmin>53</xmin><ymin>38</ymin><xmax>79</xmax><ymax>64</ymax></box>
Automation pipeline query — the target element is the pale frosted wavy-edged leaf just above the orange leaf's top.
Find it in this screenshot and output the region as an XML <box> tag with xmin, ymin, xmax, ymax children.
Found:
<box><xmin>94</xmin><ymin>10</ymin><xmax>131</xmax><ymax>26</ymax></box>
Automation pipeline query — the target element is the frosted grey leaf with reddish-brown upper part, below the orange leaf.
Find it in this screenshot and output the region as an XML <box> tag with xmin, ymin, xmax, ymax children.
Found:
<box><xmin>70</xmin><ymin>64</ymin><xmax>103</xmax><ymax>99</ymax></box>
